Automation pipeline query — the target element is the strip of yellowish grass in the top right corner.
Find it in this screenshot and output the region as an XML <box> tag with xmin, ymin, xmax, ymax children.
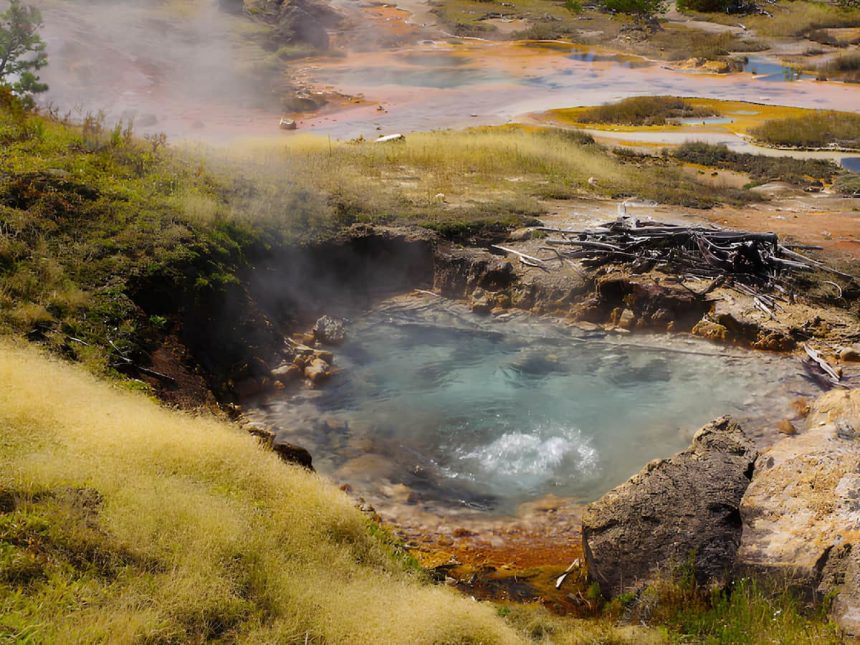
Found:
<box><xmin>689</xmin><ymin>0</ymin><xmax>860</xmax><ymax>38</ymax></box>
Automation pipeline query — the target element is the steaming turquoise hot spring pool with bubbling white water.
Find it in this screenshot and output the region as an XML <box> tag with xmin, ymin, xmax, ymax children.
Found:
<box><xmin>252</xmin><ymin>296</ymin><xmax>812</xmax><ymax>516</ymax></box>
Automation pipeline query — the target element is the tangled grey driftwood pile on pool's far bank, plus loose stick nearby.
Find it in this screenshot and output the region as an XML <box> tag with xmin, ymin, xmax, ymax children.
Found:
<box><xmin>495</xmin><ymin>216</ymin><xmax>856</xmax><ymax>387</ymax></box>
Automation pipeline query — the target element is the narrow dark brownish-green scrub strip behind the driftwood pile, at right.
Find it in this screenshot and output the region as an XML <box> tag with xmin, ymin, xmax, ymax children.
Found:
<box><xmin>671</xmin><ymin>142</ymin><xmax>840</xmax><ymax>186</ymax></box>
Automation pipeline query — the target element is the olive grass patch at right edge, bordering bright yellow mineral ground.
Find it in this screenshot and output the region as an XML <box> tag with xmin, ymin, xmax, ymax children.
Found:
<box><xmin>750</xmin><ymin>112</ymin><xmax>860</xmax><ymax>149</ymax></box>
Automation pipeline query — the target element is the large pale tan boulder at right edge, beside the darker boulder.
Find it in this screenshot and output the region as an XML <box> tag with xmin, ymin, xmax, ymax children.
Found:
<box><xmin>738</xmin><ymin>390</ymin><xmax>860</xmax><ymax>636</ymax></box>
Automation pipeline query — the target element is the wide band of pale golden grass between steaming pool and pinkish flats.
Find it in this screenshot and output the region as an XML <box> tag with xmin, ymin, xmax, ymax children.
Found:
<box><xmin>203</xmin><ymin>126</ymin><xmax>752</xmax><ymax>231</ymax></box>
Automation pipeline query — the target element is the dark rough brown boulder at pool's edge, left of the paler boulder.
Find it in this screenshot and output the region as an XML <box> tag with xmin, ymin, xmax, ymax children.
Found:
<box><xmin>582</xmin><ymin>417</ymin><xmax>757</xmax><ymax>597</ymax></box>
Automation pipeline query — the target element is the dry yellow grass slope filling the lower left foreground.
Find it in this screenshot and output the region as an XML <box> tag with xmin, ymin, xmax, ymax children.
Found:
<box><xmin>0</xmin><ymin>341</ymin><xmax>521</xmax><ymax>643</ymax></box>
